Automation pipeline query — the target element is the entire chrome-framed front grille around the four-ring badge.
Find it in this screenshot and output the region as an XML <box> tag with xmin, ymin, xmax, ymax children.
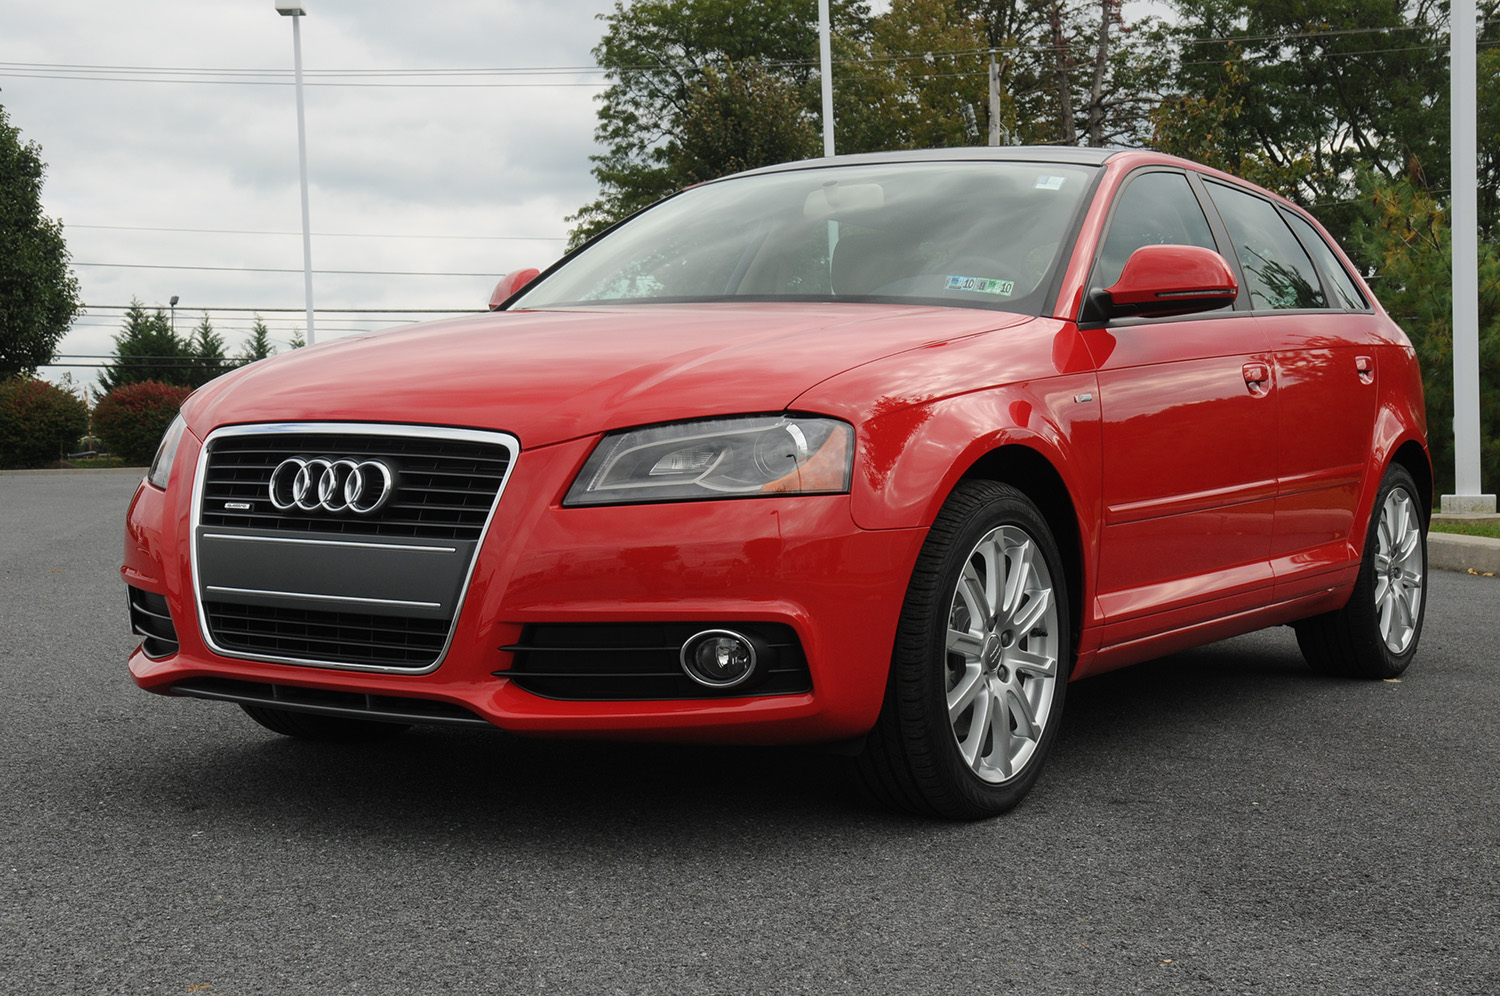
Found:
<box><xmin>194</xmin><ymin>423</ymin><xmax>519</xmax><ymax>672</ymax></box>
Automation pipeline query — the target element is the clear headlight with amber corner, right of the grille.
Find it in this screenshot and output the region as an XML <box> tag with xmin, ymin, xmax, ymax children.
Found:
<box><xmin>563</xmin><ymin>416</ymin><xmax>854</xmax><ymax>506</ymax></box>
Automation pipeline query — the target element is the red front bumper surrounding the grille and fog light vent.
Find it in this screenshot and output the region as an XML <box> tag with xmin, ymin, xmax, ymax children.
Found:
<box><xmin>123</xmin><ymin>435</ymin><xmax>926</xmax><ymax>743</ymax></box>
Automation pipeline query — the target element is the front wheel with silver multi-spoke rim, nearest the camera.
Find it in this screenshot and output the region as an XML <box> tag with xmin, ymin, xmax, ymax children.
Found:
<box><xmin>858</xmin><ymin>482</ymin><xmax>1073</xmax><ymax>819</ymax></box>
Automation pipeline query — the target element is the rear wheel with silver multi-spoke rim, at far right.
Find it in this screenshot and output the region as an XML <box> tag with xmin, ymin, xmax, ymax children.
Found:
<box><xmin>1295</xmin><ymin>464</ymin><xmax>1427</xmax><ymax>678</ymax></box>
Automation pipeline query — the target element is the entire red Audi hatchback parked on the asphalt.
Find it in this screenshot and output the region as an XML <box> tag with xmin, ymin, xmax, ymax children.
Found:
<box><xmin>123</xmin><ymin>149</ymin><xmax>1433</xmax><ymax>818</ymax></box>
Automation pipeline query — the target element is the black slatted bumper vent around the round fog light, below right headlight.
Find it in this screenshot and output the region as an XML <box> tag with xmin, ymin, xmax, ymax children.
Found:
<box><xmin>495</xmin><ymin>623</ymin><xmax>813</xmax><ymax>702</ymax></box>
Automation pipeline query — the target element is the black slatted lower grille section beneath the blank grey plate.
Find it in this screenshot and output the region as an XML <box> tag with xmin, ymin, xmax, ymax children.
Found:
<box><xmin>203</xmin><ymin>602</ymin><xmax>449</xmax><ymax>669</ymax></box>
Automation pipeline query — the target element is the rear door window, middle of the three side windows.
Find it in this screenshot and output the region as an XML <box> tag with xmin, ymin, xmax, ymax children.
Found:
<box><xmin>1206</xmin><ymin>182</ymin><xmax>1328</xmax><ymax>311</ymax></box>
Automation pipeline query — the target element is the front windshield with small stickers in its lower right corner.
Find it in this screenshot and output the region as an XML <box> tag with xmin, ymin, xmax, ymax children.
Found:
<box><xmin>510</xmin><ymin>162</ymin><xmax>1094</xmax><ymax>314</ymax></box>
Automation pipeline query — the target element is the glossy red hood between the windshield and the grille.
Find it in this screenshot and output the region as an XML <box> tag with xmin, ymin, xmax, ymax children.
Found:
<box><xmin>185</xmin><ymin>303</ymin><xmax>1028</xmax><ymax>447</ymax></box>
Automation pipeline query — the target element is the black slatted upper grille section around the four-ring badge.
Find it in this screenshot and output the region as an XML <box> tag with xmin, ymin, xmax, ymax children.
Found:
<box><xmin>200</xmin><ymin>431</ymin><xmax>510</xmax><ymax>540</ymax></box>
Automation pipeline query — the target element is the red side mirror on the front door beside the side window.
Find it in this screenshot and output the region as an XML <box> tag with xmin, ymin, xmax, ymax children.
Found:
<box><xmin>1095</xmin><ymin>246</ymin><xmax>1239</xmax><ymax>318</ymax></box>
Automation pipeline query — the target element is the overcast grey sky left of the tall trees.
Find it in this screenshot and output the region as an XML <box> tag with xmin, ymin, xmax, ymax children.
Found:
<box><xmin>0</xmin><ymin>0</ymin><xmax>627</xmax><ymax>381</ymax></box>
